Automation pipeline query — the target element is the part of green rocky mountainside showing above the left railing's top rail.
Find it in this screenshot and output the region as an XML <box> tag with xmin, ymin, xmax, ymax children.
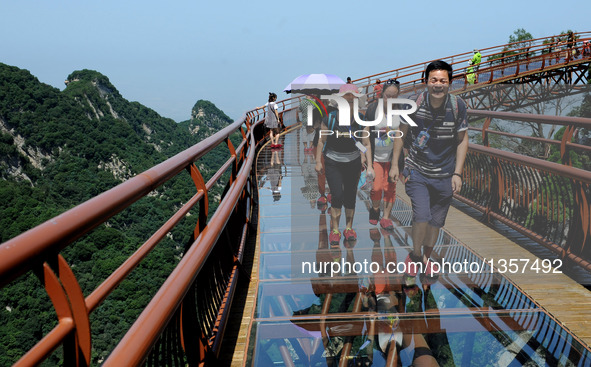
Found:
<box><xmin>0</xmin><ymin>63</ymin><xmax>236</xmax><ymax>236</ymax></box>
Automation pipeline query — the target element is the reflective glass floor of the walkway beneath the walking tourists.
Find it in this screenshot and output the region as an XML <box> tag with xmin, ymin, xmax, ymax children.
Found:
<box><xmin>251</xmin><ymin>131</ymin><xmax>591</xmax><ymax>366</ymax></box>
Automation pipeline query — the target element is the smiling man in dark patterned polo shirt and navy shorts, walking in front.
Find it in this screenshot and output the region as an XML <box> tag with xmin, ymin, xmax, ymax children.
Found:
<box><xmin>390</xmin><ymin>60</ymin><xmax>468</xmax><ymax>276</ymax></box>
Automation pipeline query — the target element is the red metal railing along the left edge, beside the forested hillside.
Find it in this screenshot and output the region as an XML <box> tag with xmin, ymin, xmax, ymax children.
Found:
<box><xmin>0</xmin><ymin>102</ymin><xmax>286</xmax><ymax>366</ymax></box>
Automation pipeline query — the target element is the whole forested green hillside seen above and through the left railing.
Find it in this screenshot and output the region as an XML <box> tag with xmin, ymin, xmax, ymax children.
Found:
<box><xmin>0</xmin><ymin>63</ymin><xmax>240</xmax><ymax>366</ymax></box>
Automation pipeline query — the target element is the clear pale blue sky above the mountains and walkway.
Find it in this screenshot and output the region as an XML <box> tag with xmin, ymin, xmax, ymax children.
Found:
<box><xmin>0</xmin><ymin>0</ymin><xmax>591</xmax><ymax>121</ymax></box>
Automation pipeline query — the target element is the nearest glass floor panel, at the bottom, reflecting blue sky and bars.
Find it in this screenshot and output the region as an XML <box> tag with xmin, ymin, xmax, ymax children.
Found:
<box><xmin>247</xmin><ymin>311</ymin><xmax>591</xmax><ymax>367</ymax></box>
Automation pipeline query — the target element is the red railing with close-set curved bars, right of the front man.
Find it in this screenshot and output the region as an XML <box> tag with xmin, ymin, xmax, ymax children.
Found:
<box><xmin>456</xmin><ymin>110</ymin><xmax>591</xmax><ymax>270</ymax></box>
